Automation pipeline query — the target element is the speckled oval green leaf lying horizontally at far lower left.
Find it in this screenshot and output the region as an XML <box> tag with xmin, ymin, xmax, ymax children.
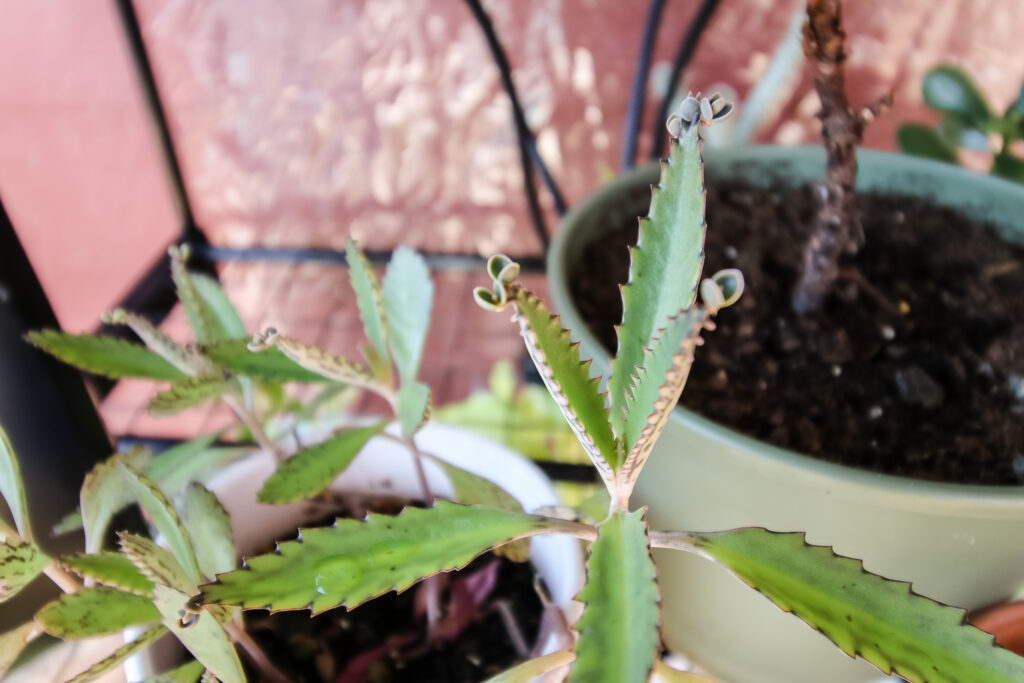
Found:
<box><xmin>36</xmin><ymin>586</ymin><xmax>160</xmax><ymax>640</ymax></box>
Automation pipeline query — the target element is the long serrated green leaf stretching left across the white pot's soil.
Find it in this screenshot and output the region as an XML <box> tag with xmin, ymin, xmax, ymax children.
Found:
<box><xmin>202</xmin><ymin>501</ymin><xmax>559</xmax><ymax>613</ymax></box>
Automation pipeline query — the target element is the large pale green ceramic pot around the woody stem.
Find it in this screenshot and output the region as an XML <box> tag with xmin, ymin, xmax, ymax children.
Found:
<box><xmin>548</xmin><ymin>146</ymin><xmax>1024</xmax><ymax>683</ymax></box>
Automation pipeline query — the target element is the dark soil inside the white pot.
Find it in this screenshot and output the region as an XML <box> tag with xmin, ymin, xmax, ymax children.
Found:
<box><xmin>245</xmin><ymin>510</ymin><xmax>543</xmax><ymax>683</ymax></box>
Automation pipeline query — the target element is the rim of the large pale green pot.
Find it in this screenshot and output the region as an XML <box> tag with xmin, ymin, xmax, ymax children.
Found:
<box><xmin>547</xmin><ymin>145</ymin><xmax>1024</xmax><ymax>505</ymax></box>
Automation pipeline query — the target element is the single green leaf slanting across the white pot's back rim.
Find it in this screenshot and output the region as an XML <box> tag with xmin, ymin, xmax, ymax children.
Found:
<box><xmin>257</xmin><ymin>422</ymin><xmax>387</xmax><ymax>504</ymax></box>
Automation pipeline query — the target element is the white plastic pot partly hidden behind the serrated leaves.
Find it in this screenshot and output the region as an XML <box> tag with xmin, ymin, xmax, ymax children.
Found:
<box><xmin>125</xmin><ymin>423</ymin><xmax>585</xmax><ymax>681</ymax></box>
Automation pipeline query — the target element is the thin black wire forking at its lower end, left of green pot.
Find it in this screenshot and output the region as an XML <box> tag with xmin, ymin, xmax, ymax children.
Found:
<box><xmin>466</xmin><ymin>0</ymin><xmax>566</xmax><ymax>252</ymax></box>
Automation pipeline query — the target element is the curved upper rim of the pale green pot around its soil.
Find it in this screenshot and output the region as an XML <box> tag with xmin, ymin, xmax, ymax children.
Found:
<box><xmin>547</xmin><ymin>145</ymin><xmax>1024</xmax><ymax>501</ymax></box>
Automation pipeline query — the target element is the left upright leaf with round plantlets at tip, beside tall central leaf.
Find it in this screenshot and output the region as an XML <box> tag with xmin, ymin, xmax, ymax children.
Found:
<box><xmin>507</xmin><ymin>285</ymin><xmax>622</xmax><ymax>481</ymax></box>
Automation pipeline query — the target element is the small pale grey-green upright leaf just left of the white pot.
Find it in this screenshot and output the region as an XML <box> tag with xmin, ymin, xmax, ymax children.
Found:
<box><xmin>181</xmin><ymin>481</ymin><xmax>238</xmax><ymax>579</ymax></box>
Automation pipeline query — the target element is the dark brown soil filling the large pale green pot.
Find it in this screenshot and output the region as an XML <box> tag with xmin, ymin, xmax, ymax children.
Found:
<box><xmin>569</xmin><ymin>185</ymin><xmax>1024</xmax><ymax>484</ymax></box>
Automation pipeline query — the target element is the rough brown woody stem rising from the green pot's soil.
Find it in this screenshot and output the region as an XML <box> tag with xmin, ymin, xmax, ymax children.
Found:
<box><xmin>793</xmin><ymin>0</ymin><xmax>892</xmax><ymax>315</ymax></box>
